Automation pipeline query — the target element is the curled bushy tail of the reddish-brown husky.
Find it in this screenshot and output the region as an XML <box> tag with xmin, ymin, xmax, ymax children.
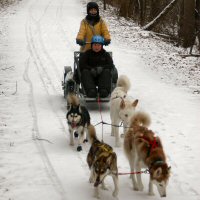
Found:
<box><xmin>131</xmin><ymin>112</ymin><xmax>151</xmax><ymax>127</ymax></box>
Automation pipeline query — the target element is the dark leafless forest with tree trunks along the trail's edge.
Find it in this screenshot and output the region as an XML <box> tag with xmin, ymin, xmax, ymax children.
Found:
<box><xmin>102</xmin><ymin>0</ymin><xmax>200</xmax><ymax>56</ymax></box>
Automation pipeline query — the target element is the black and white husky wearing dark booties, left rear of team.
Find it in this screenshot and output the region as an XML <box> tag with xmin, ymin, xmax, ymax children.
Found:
<box><xmin>66</xmin><ymin>94</ymin><xmax>90</xmax><ymax>151</ymax></box>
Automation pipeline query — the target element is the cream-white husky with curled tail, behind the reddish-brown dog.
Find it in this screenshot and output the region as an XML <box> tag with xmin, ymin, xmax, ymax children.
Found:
<box><xmin>110</xmin><ymin>75</ymin><xmax>138</xmax><ymax>147</ymax></box>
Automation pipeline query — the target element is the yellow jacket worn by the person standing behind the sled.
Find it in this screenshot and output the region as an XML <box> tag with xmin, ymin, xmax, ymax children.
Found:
<box><xmin>76</xmin><ymin>18</ymin><xmax>111</xmax><ymax>52</ymax></box>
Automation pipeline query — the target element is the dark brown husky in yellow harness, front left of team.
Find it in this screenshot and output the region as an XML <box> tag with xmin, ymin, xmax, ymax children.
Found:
<box><xmin>87</xmin><ymin>125</ymin><xmax>119</xmax><ymax>198</ymax></box>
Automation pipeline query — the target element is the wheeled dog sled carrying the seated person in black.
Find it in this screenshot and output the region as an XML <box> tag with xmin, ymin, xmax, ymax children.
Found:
<box><xmin>62</xmin><ymin>51</ymin><xmax>118</xmax><ymax>102</ymax></box>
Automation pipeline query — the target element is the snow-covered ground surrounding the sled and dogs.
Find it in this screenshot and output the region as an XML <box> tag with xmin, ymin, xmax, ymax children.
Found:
<box><xmin>0</xmin><ymin>0</ymin><xmax>200</xmax><ymax>200</ymax></box>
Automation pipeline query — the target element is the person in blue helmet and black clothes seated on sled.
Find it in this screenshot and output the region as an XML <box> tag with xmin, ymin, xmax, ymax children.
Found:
<box><xmin>79</xmin><ymin>35</ymin><xmax>114</xmax><ymax>98</ymax></box>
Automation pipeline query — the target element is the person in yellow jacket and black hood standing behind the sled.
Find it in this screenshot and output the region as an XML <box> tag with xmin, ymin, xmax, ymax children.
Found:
<box><xmin>76</xmin><ymin>2</ymin><xmax>111</xmax><ymax>52</ymax></box>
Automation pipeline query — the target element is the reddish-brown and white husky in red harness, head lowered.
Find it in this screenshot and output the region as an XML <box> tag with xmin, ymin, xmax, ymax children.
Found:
<box><xmin>124</xmin><ymin>112</ymin><xmax>170</xmax><ymax>197</ymax></box>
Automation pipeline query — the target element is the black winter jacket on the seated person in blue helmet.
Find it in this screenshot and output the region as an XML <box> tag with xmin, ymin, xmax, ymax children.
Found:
<box><xmin>79</xmin><ymin>49</ymin><xmax>114</xmax><ymax>71</ymax></box>
